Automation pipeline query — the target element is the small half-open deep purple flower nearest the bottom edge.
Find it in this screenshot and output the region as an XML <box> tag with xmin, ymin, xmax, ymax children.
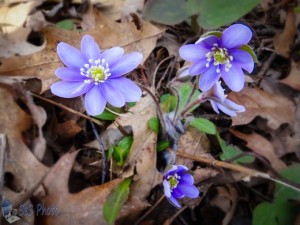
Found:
<box><xmin>163</xmin><ymin>165</ymin><xmax>199</xmax><ymax>208</ymax></box>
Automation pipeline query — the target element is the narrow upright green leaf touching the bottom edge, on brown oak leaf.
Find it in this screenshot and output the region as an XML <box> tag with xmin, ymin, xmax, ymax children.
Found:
<box><xmin>103</xmin><ymin>177</ymin><xmax>131</xmax><ymax>225</ymax></box>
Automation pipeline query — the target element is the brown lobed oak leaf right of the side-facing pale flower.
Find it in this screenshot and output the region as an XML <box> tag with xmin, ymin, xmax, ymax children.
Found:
<box><xmin>228</xmin><ymin>87</ymin><xmax>295</xmax><ymax>130</ymax></box>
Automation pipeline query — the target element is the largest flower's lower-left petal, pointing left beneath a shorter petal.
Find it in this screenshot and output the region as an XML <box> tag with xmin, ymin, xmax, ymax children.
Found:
<box><xmin>51</xmin><ymin>81</ymin><xmax>94</xmax><ymax>98</ymax></box>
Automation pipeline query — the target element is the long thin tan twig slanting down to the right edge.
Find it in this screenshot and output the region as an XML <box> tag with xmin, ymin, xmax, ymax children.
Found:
<box><xmin>176</xmin><ymin>151</ymin><xmax>300</xmax><ymax>192</ymax></box>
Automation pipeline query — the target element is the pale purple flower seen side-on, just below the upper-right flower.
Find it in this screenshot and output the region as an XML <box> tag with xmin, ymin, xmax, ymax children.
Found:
<box><xmin>204</xmin><ymin>82</ymin><xmax>245</xmax><ymax>116</ymax></box>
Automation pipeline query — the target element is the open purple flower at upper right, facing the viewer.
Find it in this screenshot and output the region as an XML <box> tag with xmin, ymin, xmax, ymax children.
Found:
<box><xmin>179</xmin><ymin>24</ymin><xmax>254</xmax><ymax>91</ymax></box>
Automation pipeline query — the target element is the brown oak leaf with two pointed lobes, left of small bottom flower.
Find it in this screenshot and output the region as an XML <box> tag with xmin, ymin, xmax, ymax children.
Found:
<box><xmin>37</xmin><ymin>151</ymin><xmax>122</xmax><ymax>225</ymax></box>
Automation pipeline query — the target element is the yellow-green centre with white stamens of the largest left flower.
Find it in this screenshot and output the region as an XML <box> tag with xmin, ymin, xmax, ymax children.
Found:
<box><xmin>80</xmin><ymin>59</ymin><xmax>111</xmax><ymax>85</ymax></box>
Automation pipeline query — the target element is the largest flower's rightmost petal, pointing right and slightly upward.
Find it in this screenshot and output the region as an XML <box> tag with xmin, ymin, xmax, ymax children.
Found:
<box><xmin>110</xmin><ymin>52</ymin><xmax>143</xmax><ymax>78</ymax></box>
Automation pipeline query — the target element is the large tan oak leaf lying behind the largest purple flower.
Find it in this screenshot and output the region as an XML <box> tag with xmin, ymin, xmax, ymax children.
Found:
<box><xmin>0</xmin><ymin>10</ymin><xmax>164</xmax><ymax>92</ymax></box>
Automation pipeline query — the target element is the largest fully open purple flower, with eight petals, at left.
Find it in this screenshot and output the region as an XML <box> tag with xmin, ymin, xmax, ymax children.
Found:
<box><xmin>51</xmin><ymin>35</ymin><xmax>143</xmax><ymax>116</ymax></box>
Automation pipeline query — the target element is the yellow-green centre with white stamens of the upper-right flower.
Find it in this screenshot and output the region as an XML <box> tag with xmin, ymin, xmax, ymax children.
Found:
<box><xmin>206</xmin><ymin>43</ymin><xmax>233</xmax><ymax>73</ymax></box>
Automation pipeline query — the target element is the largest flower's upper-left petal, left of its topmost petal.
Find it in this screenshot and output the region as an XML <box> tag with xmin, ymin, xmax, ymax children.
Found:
<box><xmin>57</xmin><ymin>42</ymin><xmax>85</xmax><ymax>69</ymax></box>
